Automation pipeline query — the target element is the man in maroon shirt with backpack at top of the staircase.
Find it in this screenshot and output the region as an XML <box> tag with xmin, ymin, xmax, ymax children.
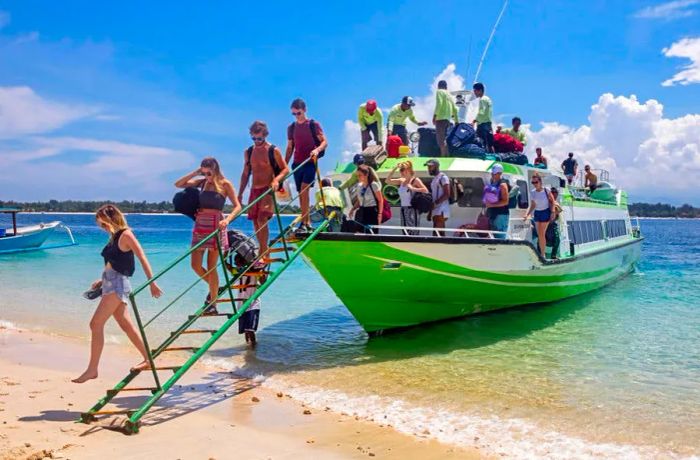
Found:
<box><xmin>285</xmin><ymin>98</ymin><xmax>328</xmax><ymax>232</ymax></box>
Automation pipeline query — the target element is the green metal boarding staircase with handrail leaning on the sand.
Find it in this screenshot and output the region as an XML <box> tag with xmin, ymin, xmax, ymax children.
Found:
<box><xmin>79</xmin><ymin>160</ymin><xmax>334</xmax><ymax>434</ymax></box>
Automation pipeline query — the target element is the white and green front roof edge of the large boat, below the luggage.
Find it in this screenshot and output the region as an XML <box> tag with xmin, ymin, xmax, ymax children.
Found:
<box><xmin>335</xmin><ymin>157</ymin><xmax>551</xmax><ymax>176</ymax></box>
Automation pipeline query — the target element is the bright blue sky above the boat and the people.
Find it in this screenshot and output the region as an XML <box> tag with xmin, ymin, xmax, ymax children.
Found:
<box><xmin>0</xmin><ymin>0</ymin><xmax>700</xmax><ymax>200</ymax></box>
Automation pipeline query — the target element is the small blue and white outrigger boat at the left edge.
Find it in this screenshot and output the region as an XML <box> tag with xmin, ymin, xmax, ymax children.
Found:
<box><xmin>0</xmin><ymin>208</ymin><xmax>78</xmax><ymax>254</ymax></box>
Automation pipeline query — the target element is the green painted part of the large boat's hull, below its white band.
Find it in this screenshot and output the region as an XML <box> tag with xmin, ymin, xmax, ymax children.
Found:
<box><xmin>304</xmin><ymin>240</ymin><xmax>640</xmax><ymax>332</ymax></box>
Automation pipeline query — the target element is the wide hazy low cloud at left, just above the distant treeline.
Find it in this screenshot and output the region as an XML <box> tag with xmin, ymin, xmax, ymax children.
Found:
<box><xmin>0</xmin><ymin>137</ymin><xmax>196</xmax><ymax>200</ymax></box>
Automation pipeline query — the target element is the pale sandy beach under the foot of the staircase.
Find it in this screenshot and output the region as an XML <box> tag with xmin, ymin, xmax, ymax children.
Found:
<box><xmin>0</xmin><ymin>329</ymin><xmax>481</xmax><ymax>460</ymax></box>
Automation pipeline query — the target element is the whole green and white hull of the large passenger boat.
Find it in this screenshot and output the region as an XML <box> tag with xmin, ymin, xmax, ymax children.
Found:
<box><xmin>304</xmin><ymin>234</ymin><xmax>641</xmax><ymax>333</ymax></box>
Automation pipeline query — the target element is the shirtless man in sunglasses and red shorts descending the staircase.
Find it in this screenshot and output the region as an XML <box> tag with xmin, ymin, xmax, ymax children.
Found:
<box><xmin>238</xmin><ymin>121</ymin><xmax>289</xmax><ymax>260</ymax></box>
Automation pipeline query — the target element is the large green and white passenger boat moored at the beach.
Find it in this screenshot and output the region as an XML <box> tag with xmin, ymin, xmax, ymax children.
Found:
<box><xmin>303</xmin><ymin>157</ymin><xmax>642</xmax><ymax>335</ymax></box>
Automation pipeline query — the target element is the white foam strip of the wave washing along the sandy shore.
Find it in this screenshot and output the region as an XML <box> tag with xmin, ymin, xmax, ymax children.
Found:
<box><xmin>198</xmin><ymin>358</ymin><xmax>682</xmax><ymax>459</ymax></box>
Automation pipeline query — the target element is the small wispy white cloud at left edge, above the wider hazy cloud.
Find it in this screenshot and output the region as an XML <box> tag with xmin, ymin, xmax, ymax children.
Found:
<box><xmin>0</xmin><ymin>86</ymin><xmax>97</xmax><ymax>139</ymax></box>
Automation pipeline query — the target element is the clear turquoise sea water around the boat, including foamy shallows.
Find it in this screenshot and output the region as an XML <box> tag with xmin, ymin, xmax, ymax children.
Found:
<box><xmin>0</xmin><ymin>214</ymin><xmax>700</xmax><ymax>458</ymax></box>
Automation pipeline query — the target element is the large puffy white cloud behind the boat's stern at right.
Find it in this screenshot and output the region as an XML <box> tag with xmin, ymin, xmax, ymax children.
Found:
<box><xmin>527</xmin><ymin>93</ymin><xmax>700</xmax><ymax>195</ymax></box>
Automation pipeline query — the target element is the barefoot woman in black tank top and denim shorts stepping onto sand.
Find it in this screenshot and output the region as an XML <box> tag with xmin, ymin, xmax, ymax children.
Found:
<box><xmin>73</xmin><ymin>204</ymin><xmax>162</xmax><ymax>383</ymax></box>
